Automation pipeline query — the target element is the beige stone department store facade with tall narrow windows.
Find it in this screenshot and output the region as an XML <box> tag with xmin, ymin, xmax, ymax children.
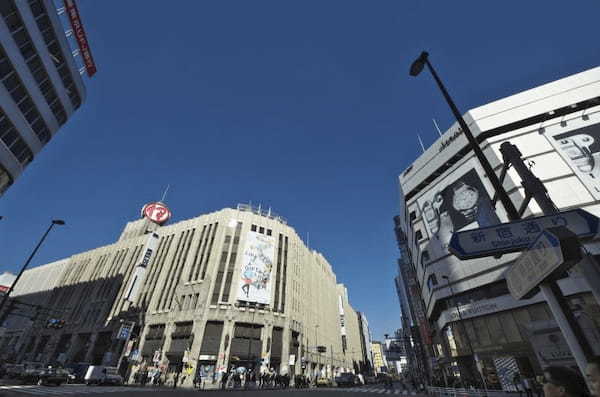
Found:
<box><xmin>4</xmin><ymin>205</ymin><xmax>364</xmax><ymax>383</ymax></box>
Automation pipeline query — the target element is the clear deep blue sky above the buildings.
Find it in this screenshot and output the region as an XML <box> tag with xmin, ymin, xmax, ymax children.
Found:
<box><xmin>0</xmin><ymin>0</ymin><xmax>600</xmax><ymax>338</ymax></box>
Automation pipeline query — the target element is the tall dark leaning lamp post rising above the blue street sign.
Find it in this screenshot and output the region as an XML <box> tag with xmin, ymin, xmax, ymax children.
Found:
<box><xmin>409</xmin><ymin>51</ymin><xmax>519</xmax><ymax>221</ymax></box>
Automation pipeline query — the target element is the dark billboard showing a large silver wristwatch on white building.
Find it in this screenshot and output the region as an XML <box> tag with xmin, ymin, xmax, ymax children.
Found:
<box><xmin>419</xmin><ymin>169</ymin><xmax>500</xmax><ymax>261</ymax></box>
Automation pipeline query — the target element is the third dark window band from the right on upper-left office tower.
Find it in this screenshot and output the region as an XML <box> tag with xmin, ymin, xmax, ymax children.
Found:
<box><xmin>0</xmin><ymin>46</ymin><xmax>50</xmax><ymax>144</ymax></box>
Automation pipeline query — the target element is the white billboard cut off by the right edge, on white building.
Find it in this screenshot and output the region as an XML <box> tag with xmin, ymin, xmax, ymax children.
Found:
<box><xmin>546</xmin><ymin>124</ymin><xmax>600</xmax><ymax>200</ymax></box>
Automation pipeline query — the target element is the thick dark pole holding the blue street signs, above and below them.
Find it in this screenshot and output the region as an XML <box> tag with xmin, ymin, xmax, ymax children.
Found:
<box><xmin>500</xmin><ymin>142</ymin><xmax>598</xmax><ymax>373</ymax></box>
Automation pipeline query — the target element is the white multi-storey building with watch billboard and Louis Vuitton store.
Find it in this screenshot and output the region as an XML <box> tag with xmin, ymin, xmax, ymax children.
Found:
<box><xmin>399</xmin><ymin>68</ymin><xmax>600</xmax><ymax>389</ymax></box>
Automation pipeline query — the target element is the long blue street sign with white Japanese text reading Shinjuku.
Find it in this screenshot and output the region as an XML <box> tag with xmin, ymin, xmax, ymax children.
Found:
<box><xmin>448</xmin><ymin>209</ymin><xmax>600</xmax><ymax>259</ymax></box>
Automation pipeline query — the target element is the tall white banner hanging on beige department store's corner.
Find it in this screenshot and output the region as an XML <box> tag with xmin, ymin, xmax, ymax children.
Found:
<box><xmin>238</xmin><ymin>232</ymin><xmax>275</xmax><ymax>305</ymax></box>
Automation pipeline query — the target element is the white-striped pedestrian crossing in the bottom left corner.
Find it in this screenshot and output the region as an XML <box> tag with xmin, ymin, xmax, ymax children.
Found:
<box><xmin>0</xmin><ymin>385</ymin><xmax>159</xmax><ymax>396</ymax></box>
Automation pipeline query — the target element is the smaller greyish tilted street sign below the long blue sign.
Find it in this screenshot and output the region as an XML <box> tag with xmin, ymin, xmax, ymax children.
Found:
<box><xmin>506</xmin><ymin>226</ymin><xmax>581</xmax><ymax>299</ymax></box>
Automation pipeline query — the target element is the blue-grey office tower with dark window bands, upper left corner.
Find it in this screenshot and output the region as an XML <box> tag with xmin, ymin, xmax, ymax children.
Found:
<box><xmin>0</xmin><ymin>0</ymin><xmax>85</xmax><ymax>195</ymax></box>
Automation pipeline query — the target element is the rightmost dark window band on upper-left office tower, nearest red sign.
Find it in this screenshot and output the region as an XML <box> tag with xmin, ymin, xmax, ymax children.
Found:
<box><xmin>29</xmin><ymin>0</ymin><xmax>81</xmax><ymax>109</ymax></box>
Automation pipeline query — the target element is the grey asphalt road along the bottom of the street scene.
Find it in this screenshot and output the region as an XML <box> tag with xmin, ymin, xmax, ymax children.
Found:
<box><xmin>0</xmin><ymin>385</ymin><xmax>419</xmax><ymax>397</ymax></box>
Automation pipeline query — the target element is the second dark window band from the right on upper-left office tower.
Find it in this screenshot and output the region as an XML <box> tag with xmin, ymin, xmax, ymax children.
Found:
<box><xmin>2</xmin><ymin>0</ymin><xmax>67</xmax><ymax>125</ymax></box>
